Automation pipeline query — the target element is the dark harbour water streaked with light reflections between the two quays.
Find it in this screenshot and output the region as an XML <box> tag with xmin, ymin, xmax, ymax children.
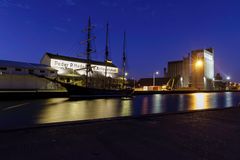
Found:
<box><xmin>0</xmin><ymin>92</ymin><xmax>240</xmax><ymax>129</ymax></box>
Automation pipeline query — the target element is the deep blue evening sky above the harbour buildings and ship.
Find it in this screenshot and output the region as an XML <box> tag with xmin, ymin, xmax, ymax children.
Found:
<box><xmin>0</xmin><ymin>0</ymin><xmax>240</xmax><ymax>81</ymax></box>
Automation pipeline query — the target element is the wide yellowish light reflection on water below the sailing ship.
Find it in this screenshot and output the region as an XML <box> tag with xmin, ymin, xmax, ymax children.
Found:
<box><xmin>37</xmin><ymin>99</ymin><xmax>133</xmax><ymax>123</ymax></box>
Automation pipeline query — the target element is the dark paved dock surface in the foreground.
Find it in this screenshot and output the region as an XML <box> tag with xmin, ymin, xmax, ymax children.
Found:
<box><xmin>0</xmin><ymin>108</ymin><xmax>240</xmax><ymax>160</ymax></box>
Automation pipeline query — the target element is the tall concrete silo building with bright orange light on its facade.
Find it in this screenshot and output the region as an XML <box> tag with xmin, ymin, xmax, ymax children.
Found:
<box><xmin>164</xmin><ymin>48</ymin><xmax>214</xmax><ymax>90</ymax></box>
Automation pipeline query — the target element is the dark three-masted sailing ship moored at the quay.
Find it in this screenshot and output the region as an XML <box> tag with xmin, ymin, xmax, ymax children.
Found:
<box><xmin>50</xmin><ymin>17</ymin><xmax>134</xmax><ymax>98</ymax></box>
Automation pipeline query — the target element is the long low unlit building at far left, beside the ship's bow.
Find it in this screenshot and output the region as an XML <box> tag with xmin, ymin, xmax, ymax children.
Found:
<box><xmin>0</xmin><ymin>60</ymin><xmax>58</xmax><ymax>90</ymax></box>
